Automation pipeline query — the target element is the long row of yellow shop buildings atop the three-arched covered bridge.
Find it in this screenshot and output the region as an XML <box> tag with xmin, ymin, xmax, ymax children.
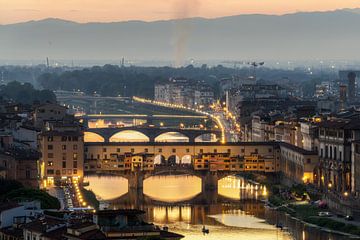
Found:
<box><xmin>85</xmin><ymin>142</ymin><xmax>280</xmax><ymax>176</ymax></box>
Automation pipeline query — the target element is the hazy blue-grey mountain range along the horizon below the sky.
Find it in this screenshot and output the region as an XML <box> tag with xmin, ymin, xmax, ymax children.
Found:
<box><xmin>0</xmin><ymin>9</ymin><xmax>360</xmax><ymax>61</ymax></box>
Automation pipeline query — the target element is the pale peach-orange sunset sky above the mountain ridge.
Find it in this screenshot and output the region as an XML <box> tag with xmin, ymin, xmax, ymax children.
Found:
<box><xmin>0</xmin><ymin>0</ymin><xmax>360</xmax><ymax>24</ymax></box>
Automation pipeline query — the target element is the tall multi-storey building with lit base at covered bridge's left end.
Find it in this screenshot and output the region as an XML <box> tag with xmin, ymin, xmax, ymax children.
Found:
<box><xmin>39</xmin><ymin>122</ymin><xmax>84</xmax><ymax>184</ymax></box>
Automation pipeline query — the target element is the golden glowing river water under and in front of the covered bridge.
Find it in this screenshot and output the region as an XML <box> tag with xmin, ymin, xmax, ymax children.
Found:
<box><xmin>85</xmin><ymin>176</ymin><xmax>347</xmax><ymax>240</ymax></box>
